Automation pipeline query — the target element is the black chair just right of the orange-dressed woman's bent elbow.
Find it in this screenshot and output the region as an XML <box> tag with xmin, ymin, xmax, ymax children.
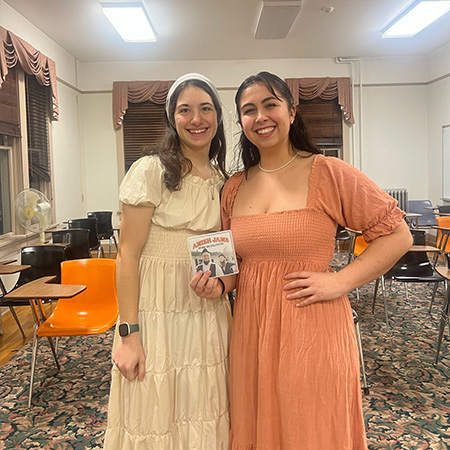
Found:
<box><xmin>372</xmin><ymin>230</ymin><xmax>444</xmax><ymax>328</ymax></box>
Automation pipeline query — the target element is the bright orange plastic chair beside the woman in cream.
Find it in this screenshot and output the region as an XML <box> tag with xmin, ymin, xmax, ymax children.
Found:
<box><xmin>29</xmin><ymin>258</ymin><xmax>119</xmax><ymax>404</ymax></box>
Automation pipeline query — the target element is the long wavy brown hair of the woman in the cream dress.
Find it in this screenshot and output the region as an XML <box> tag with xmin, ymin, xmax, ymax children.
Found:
<box><xmin>143</xmin><ymin>79</ymin><xmax>228</xmax><ymax>191</ymax></box>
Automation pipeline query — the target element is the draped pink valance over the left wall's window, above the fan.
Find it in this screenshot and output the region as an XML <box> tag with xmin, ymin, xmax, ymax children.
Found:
<box><xmin>0</xmin><ymin>26</ymin><xmax>59</xmax><ymax>120</ymax></box>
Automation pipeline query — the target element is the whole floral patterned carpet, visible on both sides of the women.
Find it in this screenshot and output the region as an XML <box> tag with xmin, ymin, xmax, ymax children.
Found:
<box><xmin>0</xmin><ymin>258</ymin><xmax>450</xmax><ymax>450</ymax></box>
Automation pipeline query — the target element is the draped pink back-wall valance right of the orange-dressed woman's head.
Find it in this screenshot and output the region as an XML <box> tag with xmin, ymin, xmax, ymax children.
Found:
<box><xmin>285</xmin><ymin>77</ymin><xmax>355</xmax><ymax>124</ymax></box>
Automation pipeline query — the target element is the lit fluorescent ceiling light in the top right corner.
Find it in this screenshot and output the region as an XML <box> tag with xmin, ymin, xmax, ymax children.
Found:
<box><xmin>381</xmin><ymin>0</ymin><xmax>450</xmax><ymax>38</ymax></box>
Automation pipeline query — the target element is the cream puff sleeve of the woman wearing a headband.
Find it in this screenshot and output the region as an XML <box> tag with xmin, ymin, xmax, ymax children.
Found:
<box><xmin>119</xmin><ymin>155</ymin><xmax>165</xmax><ymax>207</ymax></box>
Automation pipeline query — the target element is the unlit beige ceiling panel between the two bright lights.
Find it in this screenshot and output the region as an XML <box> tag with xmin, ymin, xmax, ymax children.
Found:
<box><xmin>255</xmin><ymin>1</ymin><xmax>303</xmax><ymax>39</ymax></box>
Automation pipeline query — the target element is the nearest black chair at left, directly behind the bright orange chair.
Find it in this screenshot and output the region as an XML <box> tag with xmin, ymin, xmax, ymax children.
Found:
<box><xmin>0</xmin><ymin>244</ymin><xmax>65</xmax><ymax>339</ymax></box>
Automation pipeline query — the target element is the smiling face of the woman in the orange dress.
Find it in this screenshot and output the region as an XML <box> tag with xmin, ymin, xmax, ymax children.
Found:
<box><xmin>238</xmin><ymin>83</ymin><xmax>295</xmax><ymax>151</ymax></box>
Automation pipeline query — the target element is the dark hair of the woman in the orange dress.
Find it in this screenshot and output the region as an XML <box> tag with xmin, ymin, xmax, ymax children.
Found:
<box><xmin>234</xmin><ymin>72</ymin><xmax>322</xmax><ymax>171</ymax></box>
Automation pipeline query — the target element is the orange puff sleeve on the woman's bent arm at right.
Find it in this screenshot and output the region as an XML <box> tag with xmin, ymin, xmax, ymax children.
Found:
<box><xmin>311</xmin><ymin>156</ymin><xmax>405</xmax><ymax>242</ymax></box>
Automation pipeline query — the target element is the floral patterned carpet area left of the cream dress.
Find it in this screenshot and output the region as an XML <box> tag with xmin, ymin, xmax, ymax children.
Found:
<box><xmin>0</xmin><ymin>330</ymin><xmax>113</xmax><ymax>450</ymax></box>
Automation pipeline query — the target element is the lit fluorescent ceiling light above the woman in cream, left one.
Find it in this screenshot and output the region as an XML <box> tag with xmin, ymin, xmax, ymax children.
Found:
<box><xmin>102</xmin><ymin>3</ymin><xmax>156</xmax><ymax>42</ymax></box>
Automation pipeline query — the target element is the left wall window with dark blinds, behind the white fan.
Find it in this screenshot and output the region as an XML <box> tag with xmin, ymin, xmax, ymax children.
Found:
<box><xmin>0</xmin><ymin>66</ymin><xmax>52</xmax><ymax>236</ymax></box>
